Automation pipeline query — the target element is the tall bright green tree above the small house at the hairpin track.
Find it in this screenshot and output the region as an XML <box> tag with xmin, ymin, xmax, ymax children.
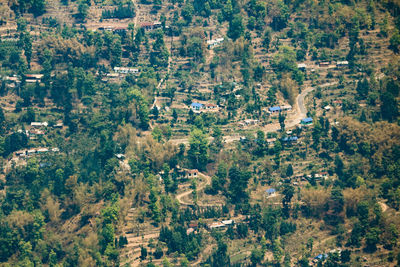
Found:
<box><xmin>188</xmin><ymin>129</ymin><xmax>208</xmax><ymax>170</ymax></box>
